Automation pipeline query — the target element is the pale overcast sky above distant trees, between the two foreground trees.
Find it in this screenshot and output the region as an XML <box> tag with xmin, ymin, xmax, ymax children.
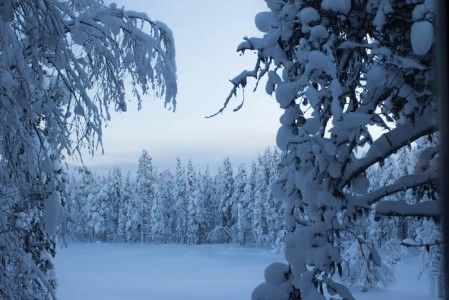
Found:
<box><xmin>70</xmin><ymin>0</ymin><xmax>280</xmax><ymax>170</ymax></box>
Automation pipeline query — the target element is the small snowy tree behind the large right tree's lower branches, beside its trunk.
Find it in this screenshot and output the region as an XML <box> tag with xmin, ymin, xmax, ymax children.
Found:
<box><xmin>341</xmin><ymin>157</ymin><xmax>403</xmax><ymax>291</ymax></box>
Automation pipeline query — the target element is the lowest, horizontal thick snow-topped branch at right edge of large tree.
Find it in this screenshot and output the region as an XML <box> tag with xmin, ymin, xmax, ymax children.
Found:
<box><xmin>376</xmin><ymin>201</ymin><xmax>440</xmax><ymax>217</ymax></box>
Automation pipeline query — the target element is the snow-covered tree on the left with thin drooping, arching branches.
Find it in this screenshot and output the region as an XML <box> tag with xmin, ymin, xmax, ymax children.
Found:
<box><xmin>0</xmin><ymin>0</ymin><xmax>176</xmax><ymax>299</ymax></box>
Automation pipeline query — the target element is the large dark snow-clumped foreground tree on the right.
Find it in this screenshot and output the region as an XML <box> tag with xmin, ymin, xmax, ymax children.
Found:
<box><xmin>219</xmin><ymin>0</ymin><xmax>439</xmax><ymax>299</ymax></box>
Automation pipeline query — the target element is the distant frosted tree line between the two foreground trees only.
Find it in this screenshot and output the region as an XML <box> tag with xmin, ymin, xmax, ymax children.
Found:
<box><xmin>60</xmin><ymin>149</ymin><xmax>285</xmax><ymax>247</ymax></box>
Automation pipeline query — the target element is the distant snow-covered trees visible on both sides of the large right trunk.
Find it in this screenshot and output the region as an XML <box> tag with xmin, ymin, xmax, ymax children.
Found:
<box><xmin>59</xmin><ymin>138</ymin><xmax>441</xmax><ymax>289</ymax></box>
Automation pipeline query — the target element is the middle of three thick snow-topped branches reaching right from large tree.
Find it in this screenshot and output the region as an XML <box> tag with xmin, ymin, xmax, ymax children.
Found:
<box><xmin>348</xmin><ymin>170</ymin><xmax>439</xmax><ymax>208</ymax></box>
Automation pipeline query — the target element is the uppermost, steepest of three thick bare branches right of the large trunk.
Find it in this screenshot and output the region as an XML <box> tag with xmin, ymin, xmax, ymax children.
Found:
<box><xmin>342</xmin><ymin>110</ymin><xmax>437</xmax><ymax>184</ymax></box>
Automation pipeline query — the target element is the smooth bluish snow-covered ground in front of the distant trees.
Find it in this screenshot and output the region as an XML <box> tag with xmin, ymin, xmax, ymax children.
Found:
<box><xmin>56</xmin><ymin>244</ymin><xmax>430</xmax><ymax>300</ymax></box>
